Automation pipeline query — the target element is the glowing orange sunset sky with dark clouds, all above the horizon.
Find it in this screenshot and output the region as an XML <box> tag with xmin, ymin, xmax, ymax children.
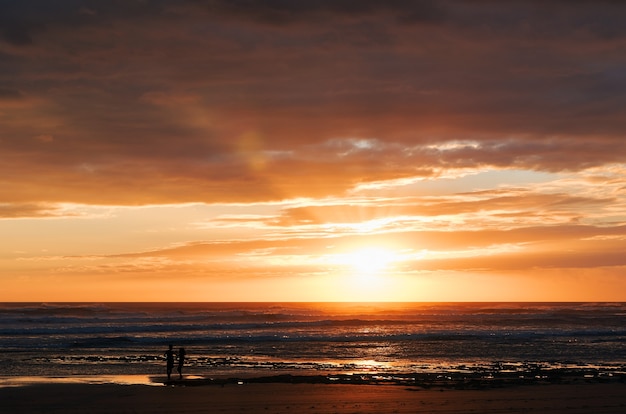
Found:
<box><xmin>0</xmin><ymin>0</ymin><xmax>626</xmax><ymax>301</ymax></box>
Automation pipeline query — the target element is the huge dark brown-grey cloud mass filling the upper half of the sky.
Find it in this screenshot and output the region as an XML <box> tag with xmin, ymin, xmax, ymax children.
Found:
<box><xmin>0</xmin><ymin>0</ymin><xmax>626</xmax><ymax>203</ymax></box>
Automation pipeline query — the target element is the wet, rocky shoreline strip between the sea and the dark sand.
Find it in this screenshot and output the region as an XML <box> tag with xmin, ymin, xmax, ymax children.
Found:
<box><xmin>0</xmin><ymin>366</ymin><xmax>626</xmax><ymax>390</ymax></box>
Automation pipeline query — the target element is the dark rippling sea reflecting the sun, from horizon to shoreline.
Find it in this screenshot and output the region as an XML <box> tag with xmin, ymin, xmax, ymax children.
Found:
<box><xmin>0</xmin><ymin>302</ymin><xmax>626</xmax><ymax>384</ymax></box>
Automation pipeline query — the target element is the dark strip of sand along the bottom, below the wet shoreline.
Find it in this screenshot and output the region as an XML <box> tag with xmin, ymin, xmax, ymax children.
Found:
<box><xmin>0</xmin><ymin>382</ymin><xmax>626</xmax><ymax>414</ymax></box>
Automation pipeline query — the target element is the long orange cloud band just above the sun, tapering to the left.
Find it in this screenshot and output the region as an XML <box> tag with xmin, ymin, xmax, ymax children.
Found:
<box><xmin>112</xmin><ymin>225</ymin><xmax>626</xmax><ymax>260</ymax></box>
